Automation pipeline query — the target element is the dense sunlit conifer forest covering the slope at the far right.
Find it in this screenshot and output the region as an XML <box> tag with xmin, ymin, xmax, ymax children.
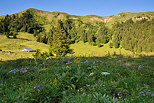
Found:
<box><xmin>112</xmin><ymin>19</ymin><xmax>154</xmax><ymax>52</ymax></box>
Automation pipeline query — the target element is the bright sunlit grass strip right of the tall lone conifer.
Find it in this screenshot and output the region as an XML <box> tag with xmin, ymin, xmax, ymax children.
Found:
<box><xmin>70</xmin><ymin>42</ymin><xmax>141</xmax><ymax>57</ymax></box>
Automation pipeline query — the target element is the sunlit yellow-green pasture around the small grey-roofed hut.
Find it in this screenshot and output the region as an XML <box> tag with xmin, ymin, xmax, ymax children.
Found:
<box><xmin>0</xmin><ymin>33</ymin><xmax>49</xmax><ymax>61</ymax></box>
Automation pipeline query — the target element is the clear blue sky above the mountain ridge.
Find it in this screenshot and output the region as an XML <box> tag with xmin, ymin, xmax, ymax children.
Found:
<box><xmin>0</xmin><ymin>0</ymin><xmax>154</xmax><ymax>16</ymax></box>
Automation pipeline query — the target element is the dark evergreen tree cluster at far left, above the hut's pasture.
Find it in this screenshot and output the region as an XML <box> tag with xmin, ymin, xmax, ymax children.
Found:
<box><xmin>0</xmin><ymin>10</ymin><xmax>43</xmax><ymax>38</ymax></box>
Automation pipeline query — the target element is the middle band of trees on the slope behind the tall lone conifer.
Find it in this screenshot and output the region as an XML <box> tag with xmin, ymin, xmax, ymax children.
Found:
<box><xmin>37</xmin><ymin>19</ymin><xmax>112</xmax><ymax>47</ymax></box>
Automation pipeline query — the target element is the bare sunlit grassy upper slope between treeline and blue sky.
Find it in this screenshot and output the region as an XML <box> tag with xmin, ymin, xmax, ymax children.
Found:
<box><xmin>3</xmin><ymin>8</ymin><xmax>154</xmax><ymax>25</ymax></box>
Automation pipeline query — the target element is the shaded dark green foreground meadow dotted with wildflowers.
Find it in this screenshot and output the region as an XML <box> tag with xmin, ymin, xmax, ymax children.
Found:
<box><xmin>0</xmin><ymin>56</ymin><xmax>154</xmax><ymax>103</ymax></box>
